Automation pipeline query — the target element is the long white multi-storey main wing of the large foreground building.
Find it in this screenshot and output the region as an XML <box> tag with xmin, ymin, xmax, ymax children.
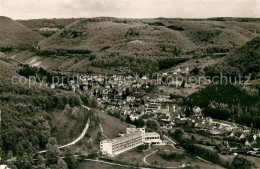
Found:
<box><xmin>100</xmin><ymin>131</ymin><xmax>145</xmax><ymax>156</ymax></box>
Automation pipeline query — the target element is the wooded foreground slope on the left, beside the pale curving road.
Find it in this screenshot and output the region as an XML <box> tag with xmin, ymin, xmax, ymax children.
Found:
<box><xmin>0</xmin><ymin>60</ymin><xmax>94</xmax><ymax>169</ymax></box>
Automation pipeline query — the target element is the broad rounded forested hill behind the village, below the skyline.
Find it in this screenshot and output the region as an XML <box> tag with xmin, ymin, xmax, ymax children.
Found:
<box><xmin>21</xmin><ymin>18</ymin><xmax>260</xmax><ymax>73</ymax></box>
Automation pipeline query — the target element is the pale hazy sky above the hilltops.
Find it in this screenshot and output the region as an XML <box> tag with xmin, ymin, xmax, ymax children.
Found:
<box><xmin>0</xmin><ymin>0</ymin><xmax>260</xmax><ymax>19</ymax></box>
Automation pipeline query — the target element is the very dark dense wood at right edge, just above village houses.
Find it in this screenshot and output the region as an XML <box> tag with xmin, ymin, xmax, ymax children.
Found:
<box><xmin>184</xmin><ymin>85</ymin><xmax>260</xmax><ymax>128</ymax></box>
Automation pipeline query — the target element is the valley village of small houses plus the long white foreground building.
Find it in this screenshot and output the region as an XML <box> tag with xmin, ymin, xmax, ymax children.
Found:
<box><xmin>47</xmin><ymin>68</ymin><xmax>260</xmax><ymax>161</ymax></box>
